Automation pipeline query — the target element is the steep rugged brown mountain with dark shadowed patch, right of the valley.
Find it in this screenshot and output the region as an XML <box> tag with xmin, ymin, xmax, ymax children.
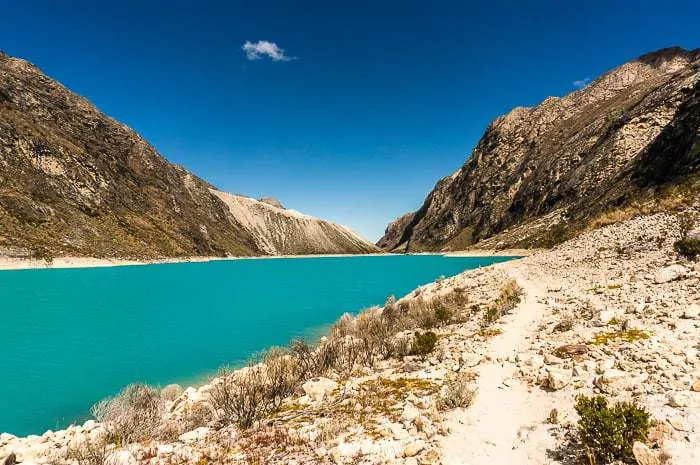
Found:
<box><xmin>377</xmin><ymin>47</ymin><xmax>700</xmax><ymax>251</ymax></box>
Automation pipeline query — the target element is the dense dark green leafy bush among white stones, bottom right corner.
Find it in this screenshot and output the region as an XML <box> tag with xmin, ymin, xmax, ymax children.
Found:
<box><xmin>575</xmin><ymin>395</ymin><xmax>649</xmax><ymax>464</ymax></box>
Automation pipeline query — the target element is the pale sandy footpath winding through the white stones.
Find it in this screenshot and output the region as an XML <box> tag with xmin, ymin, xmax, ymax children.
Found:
<box><xmin>442</xmin><ymin>269</ymin><xmax>557</xmax><ymax>465</ymax></box>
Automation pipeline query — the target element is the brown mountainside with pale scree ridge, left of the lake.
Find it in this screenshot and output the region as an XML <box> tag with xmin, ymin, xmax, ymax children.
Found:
<box><xmin>0</xmin><ymin>52</ymin><xmax>377</xmax><ymax>258</ymax></box>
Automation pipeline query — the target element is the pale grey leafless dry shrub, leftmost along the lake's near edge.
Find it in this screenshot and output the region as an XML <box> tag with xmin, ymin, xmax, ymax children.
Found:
<box><xmin>92</xmin><ymin>384</ymin><xmax>165</xmax><ymax>444</ymax></box>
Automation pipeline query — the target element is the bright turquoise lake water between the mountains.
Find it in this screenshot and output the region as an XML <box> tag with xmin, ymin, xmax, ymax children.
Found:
<box><xmin>0</xmin><ymin>255</ymin><xmax>509</xmax><ymax>435</ymax></box>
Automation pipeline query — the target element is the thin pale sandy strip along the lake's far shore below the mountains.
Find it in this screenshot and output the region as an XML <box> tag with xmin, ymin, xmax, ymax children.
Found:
<box><xmin>0</xmin><ymin>249</ymin><xmax>535</xmax><ymax>271</ymax></box>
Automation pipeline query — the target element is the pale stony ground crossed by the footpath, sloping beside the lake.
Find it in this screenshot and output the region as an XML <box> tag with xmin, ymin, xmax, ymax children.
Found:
<box><xmin>0</xmin><ymin>214</ymin><xmax>700</xmax><ymax>465</ymax></box>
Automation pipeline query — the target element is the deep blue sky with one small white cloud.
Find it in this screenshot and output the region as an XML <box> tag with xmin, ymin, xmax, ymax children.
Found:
<box><xmin>0</xmin><ymin>0</ymin><xmax>700</xmax><ymax>240</ymax></box>
